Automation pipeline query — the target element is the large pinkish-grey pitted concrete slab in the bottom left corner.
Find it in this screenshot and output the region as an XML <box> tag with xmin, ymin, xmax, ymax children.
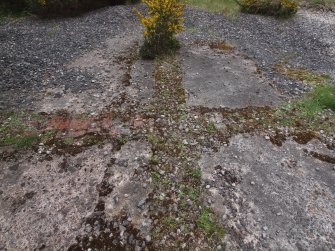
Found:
<box><xmin>0</xmin><ymin>146</ymin><xmax>112</xmax><ymax>250</ymax></box>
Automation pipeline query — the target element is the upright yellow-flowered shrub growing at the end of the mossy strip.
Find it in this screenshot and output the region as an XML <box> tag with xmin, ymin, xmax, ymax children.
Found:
<box><xmin>135</xmin><ymin>0</ymin><xmax>185</xmax><ymax>59</ymax></box>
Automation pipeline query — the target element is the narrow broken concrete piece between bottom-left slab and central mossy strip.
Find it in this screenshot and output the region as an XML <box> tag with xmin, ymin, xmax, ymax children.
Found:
<box><xmin>105</xmin><ymin>142</ymin><xmax>152</xmax><ymax>237</ymax></box>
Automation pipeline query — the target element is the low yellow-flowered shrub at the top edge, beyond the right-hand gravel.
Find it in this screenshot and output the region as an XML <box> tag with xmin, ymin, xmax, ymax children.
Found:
<box><xmin>236</xmin><ymin>0</ymin><xmax>298</xmax><ymax>16</ymax></box>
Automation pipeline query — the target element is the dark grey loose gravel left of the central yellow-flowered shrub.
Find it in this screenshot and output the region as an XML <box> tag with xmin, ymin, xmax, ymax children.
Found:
<box><xmin>0</xmin><ymin>6</ymin><xmax>137</xmax><ymax>109</ymax></box>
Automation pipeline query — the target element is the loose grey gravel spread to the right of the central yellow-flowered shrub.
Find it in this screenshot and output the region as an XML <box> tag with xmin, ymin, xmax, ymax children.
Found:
<box><xmin>183</xmin><ymin>9</ymin><xmax>335</xmax><ymax>95</ymax></box>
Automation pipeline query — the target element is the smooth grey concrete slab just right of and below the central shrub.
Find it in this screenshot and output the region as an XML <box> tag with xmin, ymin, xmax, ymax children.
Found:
<box><xmin>180</xmin><ymin>46</ymin><xmax>280</xmax><ymax>108</ymax></box>
